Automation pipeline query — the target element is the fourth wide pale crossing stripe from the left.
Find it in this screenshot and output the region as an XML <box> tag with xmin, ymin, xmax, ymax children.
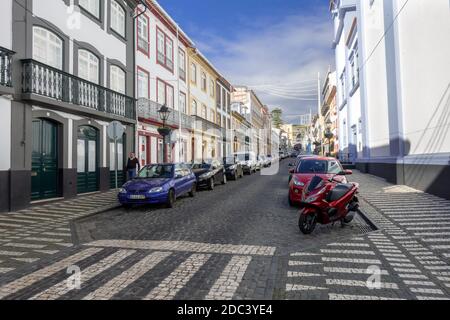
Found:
<box><xmin>144</xmin><ymin>254</ymin><xmax>211</xmax><ymax>300</ymax></box>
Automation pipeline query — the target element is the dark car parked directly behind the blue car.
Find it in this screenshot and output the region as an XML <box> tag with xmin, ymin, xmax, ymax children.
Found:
<box><xmin>191</xmin><ymin>160</ymin><xmax>227</xmax><ymax>190</ymax></box>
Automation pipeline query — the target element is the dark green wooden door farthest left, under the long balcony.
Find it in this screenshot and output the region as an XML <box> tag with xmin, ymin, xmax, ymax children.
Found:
<box><xmin>31</xmin><ymin>119</ymin><xmax>58</xmax><ymax>201</ymax></box>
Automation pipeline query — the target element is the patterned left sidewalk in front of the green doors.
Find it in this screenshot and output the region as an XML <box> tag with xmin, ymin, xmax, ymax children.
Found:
<box><xmin>0</xmin><ymin>191</ymin><xmax>118</xmax><ymax>275</ymax></box>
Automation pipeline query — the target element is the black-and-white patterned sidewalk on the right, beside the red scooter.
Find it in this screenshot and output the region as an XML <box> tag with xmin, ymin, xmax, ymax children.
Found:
<box><xmin>286</xmin><ymin>171</ymin><xmax>450</xmax><ymax>300</ymax></box>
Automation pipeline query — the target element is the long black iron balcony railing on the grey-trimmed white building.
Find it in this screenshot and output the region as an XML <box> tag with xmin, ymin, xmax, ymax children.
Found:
<box><xmin>22</xmin><ymin>59</ymin><xmax>136</xmax><ymax>120</ymax></box>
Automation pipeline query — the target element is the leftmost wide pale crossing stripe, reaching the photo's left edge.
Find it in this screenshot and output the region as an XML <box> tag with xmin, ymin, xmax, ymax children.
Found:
<box><xmin>0</xmin><ymin>248</ymin><xmax>103</xmax><ymax>299</ymax></box>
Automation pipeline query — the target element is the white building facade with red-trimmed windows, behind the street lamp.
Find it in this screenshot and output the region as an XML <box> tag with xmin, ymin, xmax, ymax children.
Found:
<box><xmin>136</xmin><ymin>1</ymin><xmax>192</xmax><ymax>165</ymax></box>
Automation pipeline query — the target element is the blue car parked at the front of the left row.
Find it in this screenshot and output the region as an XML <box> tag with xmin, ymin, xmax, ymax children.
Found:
<box><xmin>118</xmin><ymin>164</ymin><xmax>197</xmax><ymax>208</ymax></box>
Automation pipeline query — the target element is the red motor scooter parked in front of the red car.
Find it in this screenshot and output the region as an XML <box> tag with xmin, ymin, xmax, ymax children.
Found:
<box><xmin>298</xmin><ymin>170</ymin><xmax>359</xmax><ymax>234</ymax></box>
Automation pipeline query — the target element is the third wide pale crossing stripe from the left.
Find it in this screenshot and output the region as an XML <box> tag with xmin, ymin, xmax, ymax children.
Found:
<box><xmin>83</xmin><ymin>252</ymin><xmax>172</xmax><ymax>300</ymax></box>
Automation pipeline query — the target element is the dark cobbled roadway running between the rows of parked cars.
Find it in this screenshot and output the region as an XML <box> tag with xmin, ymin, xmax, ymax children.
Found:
<box><xmin>73</xmin><ymin>160</ymin><xmax>368</xmax><ymax>254</ymax></box>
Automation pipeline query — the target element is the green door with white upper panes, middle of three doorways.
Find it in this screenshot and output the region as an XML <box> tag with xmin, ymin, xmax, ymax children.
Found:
<box><xmin>77</xmin><ymin>126</ymin><xmax>99</xmax><ymax>194</ymax></box>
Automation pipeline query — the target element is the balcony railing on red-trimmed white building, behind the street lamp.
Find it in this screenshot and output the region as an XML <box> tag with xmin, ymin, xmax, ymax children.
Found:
<box><xmin>138</xmin><ymin>98</ymin><xmax>193</xmax><ymax>130</ymax></box>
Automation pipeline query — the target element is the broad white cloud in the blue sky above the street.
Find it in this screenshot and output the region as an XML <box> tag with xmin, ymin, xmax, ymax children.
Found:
<box><xmin>190</xmin><ymin>7</ymin><xmax>334</xmax><ymax>122</ymax></box>
